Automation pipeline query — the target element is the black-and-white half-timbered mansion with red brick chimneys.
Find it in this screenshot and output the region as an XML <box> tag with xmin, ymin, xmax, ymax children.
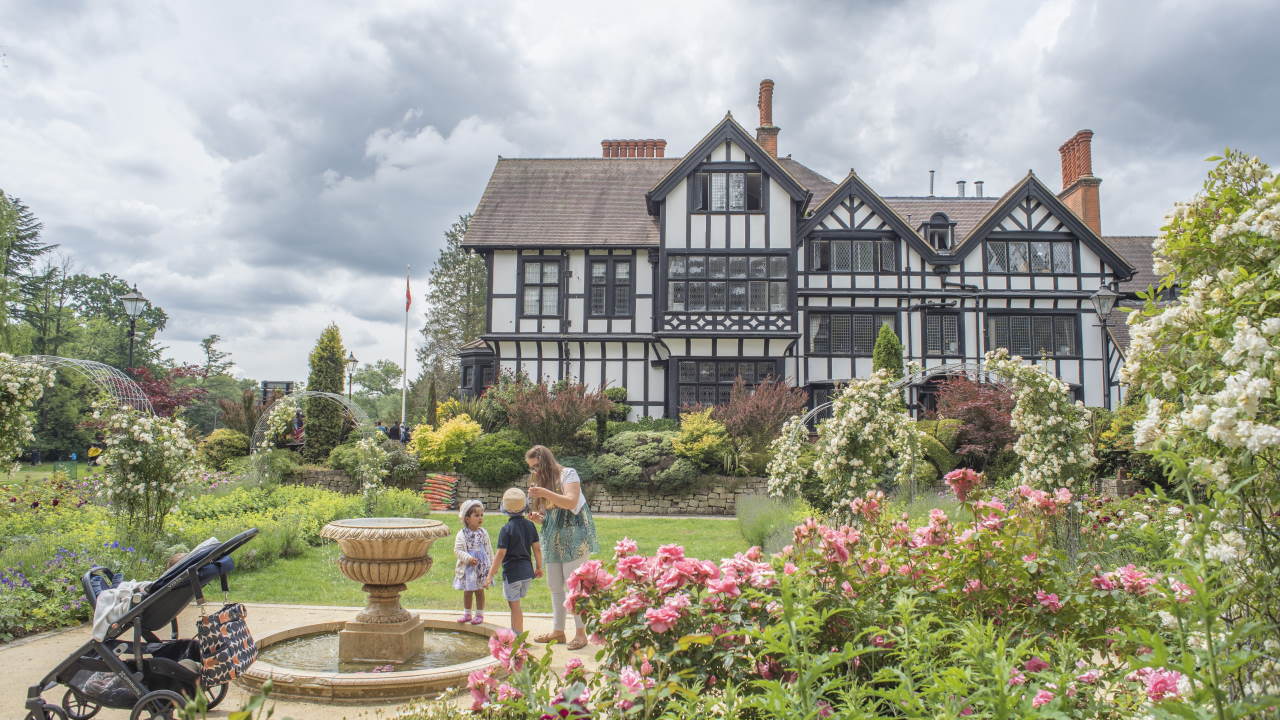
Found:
<box><xmin>461</xmin><ymin>81</ymin><xmax>1153</xmax><ymax>416</ymax></box>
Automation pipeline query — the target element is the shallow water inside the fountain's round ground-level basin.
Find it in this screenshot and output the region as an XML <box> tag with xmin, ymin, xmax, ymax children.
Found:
<box><xmin>259</xmin><ymin>630</ymin><xmax>489</xmax><ymax>673</ymax></box>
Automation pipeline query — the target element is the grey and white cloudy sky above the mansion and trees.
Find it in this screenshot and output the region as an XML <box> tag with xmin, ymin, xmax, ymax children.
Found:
<box><xmin>0</xmin><ymin>0</ymin><xmax>1280</xmax><ymax>379</ymax></box>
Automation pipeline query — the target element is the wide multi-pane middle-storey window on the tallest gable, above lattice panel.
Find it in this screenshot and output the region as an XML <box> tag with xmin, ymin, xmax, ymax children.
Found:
<box><xmin>662</xmin><ymin>247</ymin><xmax>795</xmax><ymax>315</ymax></box>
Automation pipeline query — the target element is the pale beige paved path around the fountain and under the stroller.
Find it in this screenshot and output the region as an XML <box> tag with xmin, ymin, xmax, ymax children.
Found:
<box><xmin>0</xmin><ymin>603</ymin><xmax>598</xmax><ymax>720</ymax></box>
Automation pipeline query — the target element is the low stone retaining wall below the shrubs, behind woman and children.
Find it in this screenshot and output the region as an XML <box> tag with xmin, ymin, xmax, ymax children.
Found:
<box><xmin>453</xmin><ymin>475</ymin><xmax>769</xmax><ymax>515</ymax></box>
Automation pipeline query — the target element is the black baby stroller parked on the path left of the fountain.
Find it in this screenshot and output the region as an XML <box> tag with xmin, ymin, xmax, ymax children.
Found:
<box><xmin>26</xmin><ymin>528</ymin><xmax>257</xmax><ymax>720</ymax></box>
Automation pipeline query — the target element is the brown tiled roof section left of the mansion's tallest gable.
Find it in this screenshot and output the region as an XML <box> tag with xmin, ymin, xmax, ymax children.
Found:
<box><xmin>462</xmin><ymin>158</ymin><xmax>680</xmax><ymax>247</ymax></box>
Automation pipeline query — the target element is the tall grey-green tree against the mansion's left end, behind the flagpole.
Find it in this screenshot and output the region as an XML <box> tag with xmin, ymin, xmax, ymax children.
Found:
<box><xmin>415</xmin><ymin>214</ymin><xmax>488</xmax><ymax>396</ymax></box>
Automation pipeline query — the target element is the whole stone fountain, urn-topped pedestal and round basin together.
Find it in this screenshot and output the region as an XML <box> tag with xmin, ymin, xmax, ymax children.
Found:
<box><xmin>237</xmin><ymin>518</ymin><xmax>497</xmax><ymax>703</ymax></box>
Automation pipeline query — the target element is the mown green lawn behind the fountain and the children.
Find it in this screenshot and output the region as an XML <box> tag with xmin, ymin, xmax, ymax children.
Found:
<box><xmin>232</xmin><ymin>512</ymin><xmax>746</xmax><ymax>612</ymax></box>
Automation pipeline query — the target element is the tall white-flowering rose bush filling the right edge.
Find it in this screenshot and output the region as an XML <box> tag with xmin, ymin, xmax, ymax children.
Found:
<box><xmin>1123</xmin><ymin>150</ymin><xmax>1280</xmax><ymax>717</ymax></box>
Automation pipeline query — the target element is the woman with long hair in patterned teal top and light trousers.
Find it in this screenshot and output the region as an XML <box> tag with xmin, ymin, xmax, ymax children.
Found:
<box><xmin>525</xmin><ymin>445</ymin><xmax>600</xmax><ymax>650</ymax></box>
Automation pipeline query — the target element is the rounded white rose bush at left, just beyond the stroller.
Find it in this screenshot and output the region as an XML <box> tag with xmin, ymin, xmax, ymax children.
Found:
<box><xmin>93</xmin><ymin>400</ymin><xmax>201</xmax><ymax>544</ymax></box>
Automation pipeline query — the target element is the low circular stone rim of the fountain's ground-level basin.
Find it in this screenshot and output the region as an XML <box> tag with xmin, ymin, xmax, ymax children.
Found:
<box><xmin>236</xmin><ymin>619</ymin><xmax>499</xmax><ymax>705</ymax></box>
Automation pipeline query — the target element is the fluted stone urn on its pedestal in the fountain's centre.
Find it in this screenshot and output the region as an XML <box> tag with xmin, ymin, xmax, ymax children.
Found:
<box><xmin>320</xmin><ymin>518</ymin><xmax>449</xmax><ymax>662</ymax></box>
